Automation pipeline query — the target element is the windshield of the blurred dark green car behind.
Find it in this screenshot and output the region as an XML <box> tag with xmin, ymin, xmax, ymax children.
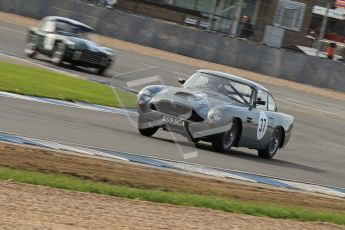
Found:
<box><xmin>55</xmin><ymin>21</ymin><xmax>93</xmax><ymax>40</ymax></box>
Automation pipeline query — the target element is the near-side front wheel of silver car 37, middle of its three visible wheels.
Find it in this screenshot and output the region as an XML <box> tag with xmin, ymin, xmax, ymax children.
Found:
<box><xmin>212</xmin><ymin>120</ymin><xmax>238</xmax><ymax>152</ymax></box>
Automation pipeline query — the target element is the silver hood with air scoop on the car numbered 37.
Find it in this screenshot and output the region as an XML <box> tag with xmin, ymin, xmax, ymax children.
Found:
<box><xmin>154</xmin><ymin>86</ymin><xmax>246</xmax><ymax>118</ymax></box>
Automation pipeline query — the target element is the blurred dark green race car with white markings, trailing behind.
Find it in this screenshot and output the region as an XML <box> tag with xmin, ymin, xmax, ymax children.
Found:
<box><xmin>25</xmin><ymin>16</ymin><xmax>115</xmax><ymax>74</ymax></box>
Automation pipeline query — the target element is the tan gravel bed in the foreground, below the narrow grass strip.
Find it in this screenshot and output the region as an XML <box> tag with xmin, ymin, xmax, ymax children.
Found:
<box><xmin>0</xmin><ymin>181</ymin><xmax>345</xmax><ymax>230</ymax></box>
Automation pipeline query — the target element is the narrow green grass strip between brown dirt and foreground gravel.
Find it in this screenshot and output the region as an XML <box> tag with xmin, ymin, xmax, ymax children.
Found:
<box><xmin>0</xmin><ymin>167</ymin><xmax>345</xmax><ymax>225</ymax></box>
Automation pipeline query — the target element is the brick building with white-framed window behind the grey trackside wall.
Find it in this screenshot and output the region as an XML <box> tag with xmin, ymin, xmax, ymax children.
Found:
<box><xmin>95</xmin><ymin>0</ymin><xmax>345</xmax><ymax>48</ymax></box>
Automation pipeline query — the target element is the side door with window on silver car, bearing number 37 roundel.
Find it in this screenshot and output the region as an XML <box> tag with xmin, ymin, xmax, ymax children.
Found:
<box><xmin>244</xmin><ymin>90</ymin><xmax>272</xmax><ymax>149</ymax></box>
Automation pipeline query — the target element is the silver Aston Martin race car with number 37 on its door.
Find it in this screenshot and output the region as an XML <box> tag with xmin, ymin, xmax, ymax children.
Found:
<box><xmin>138</xmin><ymin>70</ymin><xmax>294</xmax><ymax>159</ymax></box>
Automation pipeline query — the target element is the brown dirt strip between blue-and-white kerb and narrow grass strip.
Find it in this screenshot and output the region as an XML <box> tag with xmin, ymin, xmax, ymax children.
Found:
<box><xmin>0</xmin><ymin>143</ymin><xmax>345</xmax><ymax>214</ymax></box>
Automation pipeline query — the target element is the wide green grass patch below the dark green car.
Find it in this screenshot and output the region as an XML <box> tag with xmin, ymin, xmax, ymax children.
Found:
<box><xmin>0</xmin><ymin>62</ymin><xmax>136</xmax><ymax>108</ymax></box>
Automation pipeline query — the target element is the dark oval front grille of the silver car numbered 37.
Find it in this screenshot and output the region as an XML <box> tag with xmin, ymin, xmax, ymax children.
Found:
<box><xmin>150</xmin><ymin>101</ymin><xmax>204</xmax><ymax>122</ymax></box>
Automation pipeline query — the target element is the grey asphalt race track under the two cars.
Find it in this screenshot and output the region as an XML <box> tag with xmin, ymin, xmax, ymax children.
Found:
<box><xmin>0</xmin><ymin>23</ymin><xmax>345</xmax><ymax>187</ymax></box>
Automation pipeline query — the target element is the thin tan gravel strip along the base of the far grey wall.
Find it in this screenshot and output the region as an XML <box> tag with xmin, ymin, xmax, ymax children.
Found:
<box><xmin>0</xmin><ymin>12</ymin><xmax>345</xmax><ymax>101</ymax></box>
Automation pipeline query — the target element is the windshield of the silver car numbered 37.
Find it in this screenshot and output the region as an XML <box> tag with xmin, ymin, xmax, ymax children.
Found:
<box><xmin>184</xmin><ymin>72</ymin><xmax>254</xmax><ymax>105</ymax></box>
